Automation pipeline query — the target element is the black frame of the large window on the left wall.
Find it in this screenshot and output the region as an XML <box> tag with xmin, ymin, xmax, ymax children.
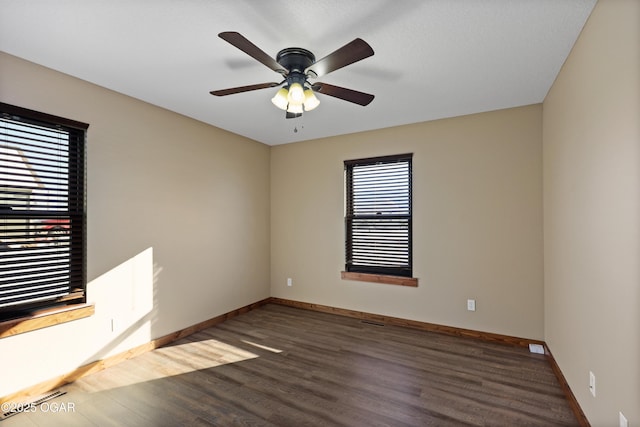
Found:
<box><xmin>0</xmin><ymin>102</ymin><xmax>89</xmax><ymax>321</ymax></box>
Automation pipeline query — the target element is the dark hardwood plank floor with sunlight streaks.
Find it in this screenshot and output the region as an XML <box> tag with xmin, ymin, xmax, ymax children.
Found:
<box><xmin>0</xmin><ymin>304</ymin><xmax>578</xmax><ymax>427</ymax></box>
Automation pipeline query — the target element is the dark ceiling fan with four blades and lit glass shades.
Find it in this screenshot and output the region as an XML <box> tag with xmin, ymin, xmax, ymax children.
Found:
<box><xmin>210</xmin><ymin>31</ymin><xmax>374</xmax><ymax>119</ymax></box>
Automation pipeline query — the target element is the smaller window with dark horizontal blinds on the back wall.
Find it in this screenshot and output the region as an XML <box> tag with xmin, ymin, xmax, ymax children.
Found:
<box><xmin>344</xmin><ymin>154</ymin><xmax>413</xmax><ymax>277</ymax></box>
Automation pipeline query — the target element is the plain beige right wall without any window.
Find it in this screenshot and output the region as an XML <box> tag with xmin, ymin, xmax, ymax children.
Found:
<box><xmin>543</xmin><ymin>0</ymin><xmax>640</xmax><ymax>426</ymax></box>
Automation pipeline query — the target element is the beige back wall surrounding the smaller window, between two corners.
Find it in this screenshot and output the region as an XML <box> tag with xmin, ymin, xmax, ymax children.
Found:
<box><xmin>271</xmin><ymin>105</ymin><xmax>544</xmax><ymax>339</ymax></box>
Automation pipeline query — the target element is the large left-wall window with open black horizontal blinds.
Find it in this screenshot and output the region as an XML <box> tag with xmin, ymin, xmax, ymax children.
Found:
<box><xmin>0</xmin><ymin>103</ymin><xmax>88</xmax><ymax>319</ymax></box>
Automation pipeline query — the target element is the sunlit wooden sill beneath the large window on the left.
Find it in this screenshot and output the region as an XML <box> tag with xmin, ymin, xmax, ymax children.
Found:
<box><xmin>0</xmin><ymin>304</ymin><xmax>95</xmax><ymax>338</ymax></box>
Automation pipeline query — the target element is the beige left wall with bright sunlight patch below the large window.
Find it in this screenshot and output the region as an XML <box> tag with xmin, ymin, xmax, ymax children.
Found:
<box><xmin>0</xmin><ymin>53</ymin><xmax>270</xmax><ymax>396</ymax></box>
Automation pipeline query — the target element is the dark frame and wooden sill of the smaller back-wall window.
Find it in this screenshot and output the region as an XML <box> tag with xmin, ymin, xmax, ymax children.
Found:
<box><xmin>342</xmin><ymin>153</ymin><xmax>417</xmax><ymax>280</ymax></box>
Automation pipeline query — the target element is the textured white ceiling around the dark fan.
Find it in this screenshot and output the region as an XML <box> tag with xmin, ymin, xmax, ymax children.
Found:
<box><xmin>0</xmin><ymin>0</ymin><xmax>596</xmax><ymax>145</ymax></box>
